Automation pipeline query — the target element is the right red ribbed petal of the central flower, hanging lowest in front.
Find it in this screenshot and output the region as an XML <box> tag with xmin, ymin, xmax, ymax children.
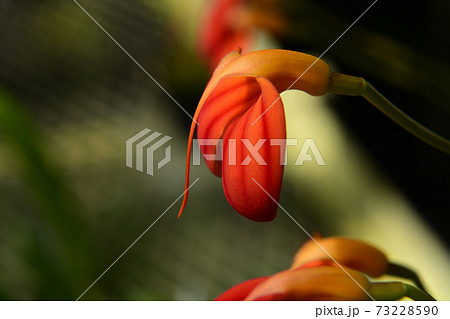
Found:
<box><xmin>222</xmin><ymin>77</ymin><xmax>286</xmax><ymax>221</ymax></box>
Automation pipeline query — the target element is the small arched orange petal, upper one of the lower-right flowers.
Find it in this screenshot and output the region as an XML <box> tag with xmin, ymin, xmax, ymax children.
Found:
<box><xmin>291</xmin><ymin>237</ymin><xmax>388</xmax><ymax>277</ymax></box>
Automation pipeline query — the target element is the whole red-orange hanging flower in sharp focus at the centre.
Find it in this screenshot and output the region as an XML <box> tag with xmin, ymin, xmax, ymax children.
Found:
<box><xmin>178</xmin><ymin>50</ymin><xmax>331</xmax><ymax>221</ymax></box>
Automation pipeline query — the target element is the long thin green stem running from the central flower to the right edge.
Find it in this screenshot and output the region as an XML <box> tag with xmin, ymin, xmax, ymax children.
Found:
<box><xmin>328</xmin><ymin>73</ymin><xmax>450</xmax><ymax>154</ymax></box>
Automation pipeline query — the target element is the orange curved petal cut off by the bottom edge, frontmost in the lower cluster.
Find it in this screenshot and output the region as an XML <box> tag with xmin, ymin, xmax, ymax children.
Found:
<box><xmin>245</xmin><ymin>266</ymin><xmax>370</xmax><ymax>301</ymax></box>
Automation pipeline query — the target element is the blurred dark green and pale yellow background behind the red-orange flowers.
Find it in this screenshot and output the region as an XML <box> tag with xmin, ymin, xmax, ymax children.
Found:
<box><xmin>0</xmin><ymin>0</ymin><xmax>450</xmax><ymax>300</ymax></box>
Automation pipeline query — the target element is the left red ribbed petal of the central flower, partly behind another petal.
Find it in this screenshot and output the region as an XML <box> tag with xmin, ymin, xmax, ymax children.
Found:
<box><xmin>197</xmin><ymin>76</ymin><xmax>261</xmax><ymax>177</ymax></box>
